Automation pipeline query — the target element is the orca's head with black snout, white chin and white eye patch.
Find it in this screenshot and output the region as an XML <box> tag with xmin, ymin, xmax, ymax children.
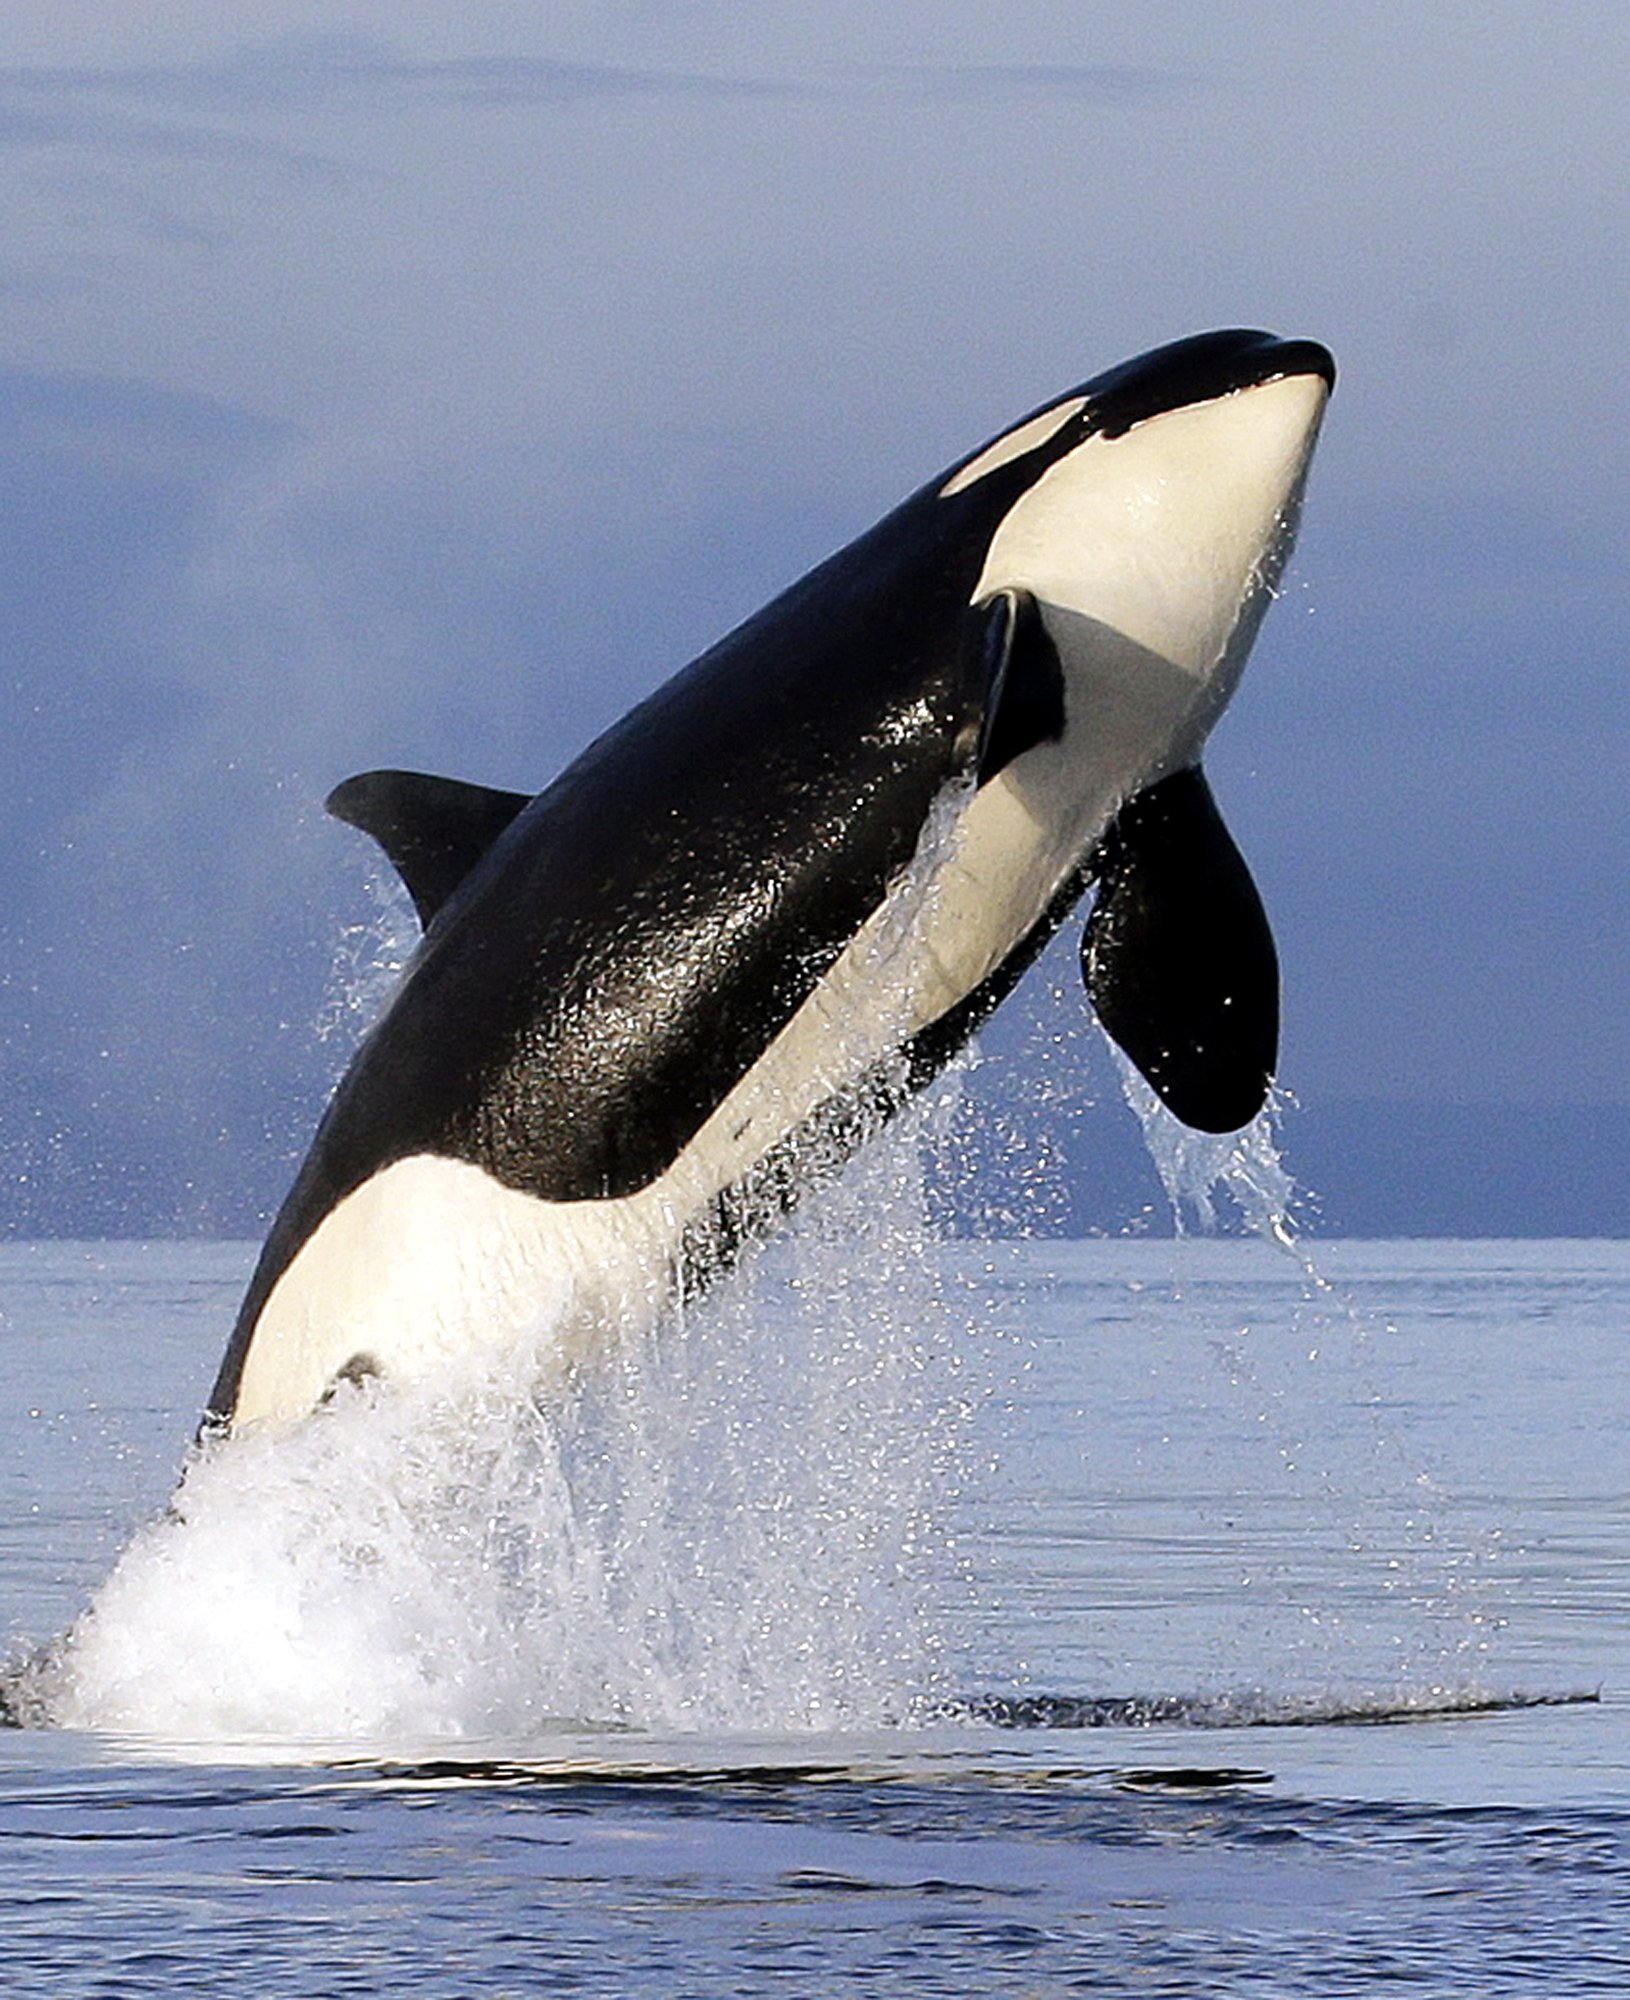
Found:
<box><xmin>938</xmin><ymin>330</ymin><xmax>1336</xmax><ymax>782</ymax></box>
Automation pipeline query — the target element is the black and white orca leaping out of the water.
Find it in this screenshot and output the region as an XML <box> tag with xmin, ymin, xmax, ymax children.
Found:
<box><xmin>206</xmin><ymin>330</ymin><xmax>1334</xmax><ymax>1430</ymax></box>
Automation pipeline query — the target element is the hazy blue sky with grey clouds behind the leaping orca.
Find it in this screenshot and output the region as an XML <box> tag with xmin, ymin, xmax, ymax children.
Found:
<box><xmin>0</xmin><ymin>0</ymin><xmax>1630</xmax><ymax>1220</ymax></box>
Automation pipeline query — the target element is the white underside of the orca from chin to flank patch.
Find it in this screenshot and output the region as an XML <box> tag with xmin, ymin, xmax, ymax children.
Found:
<box><xmin>234</xmin><ymin>376</ymin><xmax>1324</xmax><ymax>1424</ymax></box>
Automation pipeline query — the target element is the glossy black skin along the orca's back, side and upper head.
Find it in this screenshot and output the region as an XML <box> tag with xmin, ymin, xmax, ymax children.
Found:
<box><xmin>210</xmin><ymin>332</ymin><xmax>1330</xmax><ymax>1422</ymax></box>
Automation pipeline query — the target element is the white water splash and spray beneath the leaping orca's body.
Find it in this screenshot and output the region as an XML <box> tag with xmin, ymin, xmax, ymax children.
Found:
<box><xmin>42</xmin><ymin>1098</ymin><xmax>968</xmax><ymax>1744</ymax></box>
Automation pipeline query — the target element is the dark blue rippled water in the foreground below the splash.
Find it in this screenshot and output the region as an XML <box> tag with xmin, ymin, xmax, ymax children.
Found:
<box><xmin>0</xmin><ymin>1744</ymin><xmax>1630</xmax><ymax>1994</ymax></box>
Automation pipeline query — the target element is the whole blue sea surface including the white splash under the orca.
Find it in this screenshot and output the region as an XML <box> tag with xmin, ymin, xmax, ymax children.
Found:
<box><xmin>0</xmin><ymin>1224</ymin><xmax>1630</xmax><ymax>2000</ymax></box>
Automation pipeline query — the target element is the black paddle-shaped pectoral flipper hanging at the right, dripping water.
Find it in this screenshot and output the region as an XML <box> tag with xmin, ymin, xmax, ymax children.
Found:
<box><xmin>1082</xmin><ymin>768</ymin><xmax>1280</xmax><ymax>1132</ymax></box>
